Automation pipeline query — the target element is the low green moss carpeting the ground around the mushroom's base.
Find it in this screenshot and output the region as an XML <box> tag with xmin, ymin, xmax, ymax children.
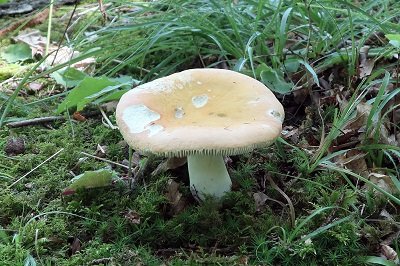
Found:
<box><xmin>0</xmin><ymin>98</ymin><xmax>390</xmax><ymax>265</ymax></box>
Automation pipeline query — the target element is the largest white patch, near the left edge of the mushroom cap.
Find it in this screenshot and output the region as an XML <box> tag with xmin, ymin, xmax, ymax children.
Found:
<box><xmin>122</xmin><ymin>104</ymin><xmax>161</xmax><ymax>134</ymax></box>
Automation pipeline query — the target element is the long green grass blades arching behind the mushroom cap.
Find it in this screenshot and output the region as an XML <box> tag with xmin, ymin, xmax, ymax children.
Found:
<box><xmin>70</xmin><ymin>0</ymin><xmax>400</xmax><ymax>85</ymax></box>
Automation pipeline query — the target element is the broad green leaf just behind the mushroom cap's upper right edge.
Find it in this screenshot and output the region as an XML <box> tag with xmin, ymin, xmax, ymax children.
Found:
<box><xmin>260</xmin><ymin>65</ymin><xmax>294</xmax><ymax>94</ymax></box>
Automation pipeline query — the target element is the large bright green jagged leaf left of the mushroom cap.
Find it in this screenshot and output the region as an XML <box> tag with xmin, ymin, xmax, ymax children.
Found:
<box><xmin>57</xmin><ymin>76</ymin><xmax>117</xmax><ymax>113</ymax></box>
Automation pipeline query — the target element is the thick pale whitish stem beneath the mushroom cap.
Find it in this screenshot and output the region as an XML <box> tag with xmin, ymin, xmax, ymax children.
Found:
<box><xmin>187</xmin><ymin>155</ymin><xmax>232</xmax><ymax>200</ymax></box>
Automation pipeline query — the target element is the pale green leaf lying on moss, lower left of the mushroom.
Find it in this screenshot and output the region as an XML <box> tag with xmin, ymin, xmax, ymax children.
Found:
<box><xmin>63</xmin><ymin>169</ymin><xmax>117</xmax><ymax>195</ymax></box>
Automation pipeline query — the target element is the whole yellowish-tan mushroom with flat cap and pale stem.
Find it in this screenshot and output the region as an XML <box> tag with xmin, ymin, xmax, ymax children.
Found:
<box><xmin>116</xmin><ymin>68</ymin><xmax>284</xmax><ymax>200</ymax></box>
